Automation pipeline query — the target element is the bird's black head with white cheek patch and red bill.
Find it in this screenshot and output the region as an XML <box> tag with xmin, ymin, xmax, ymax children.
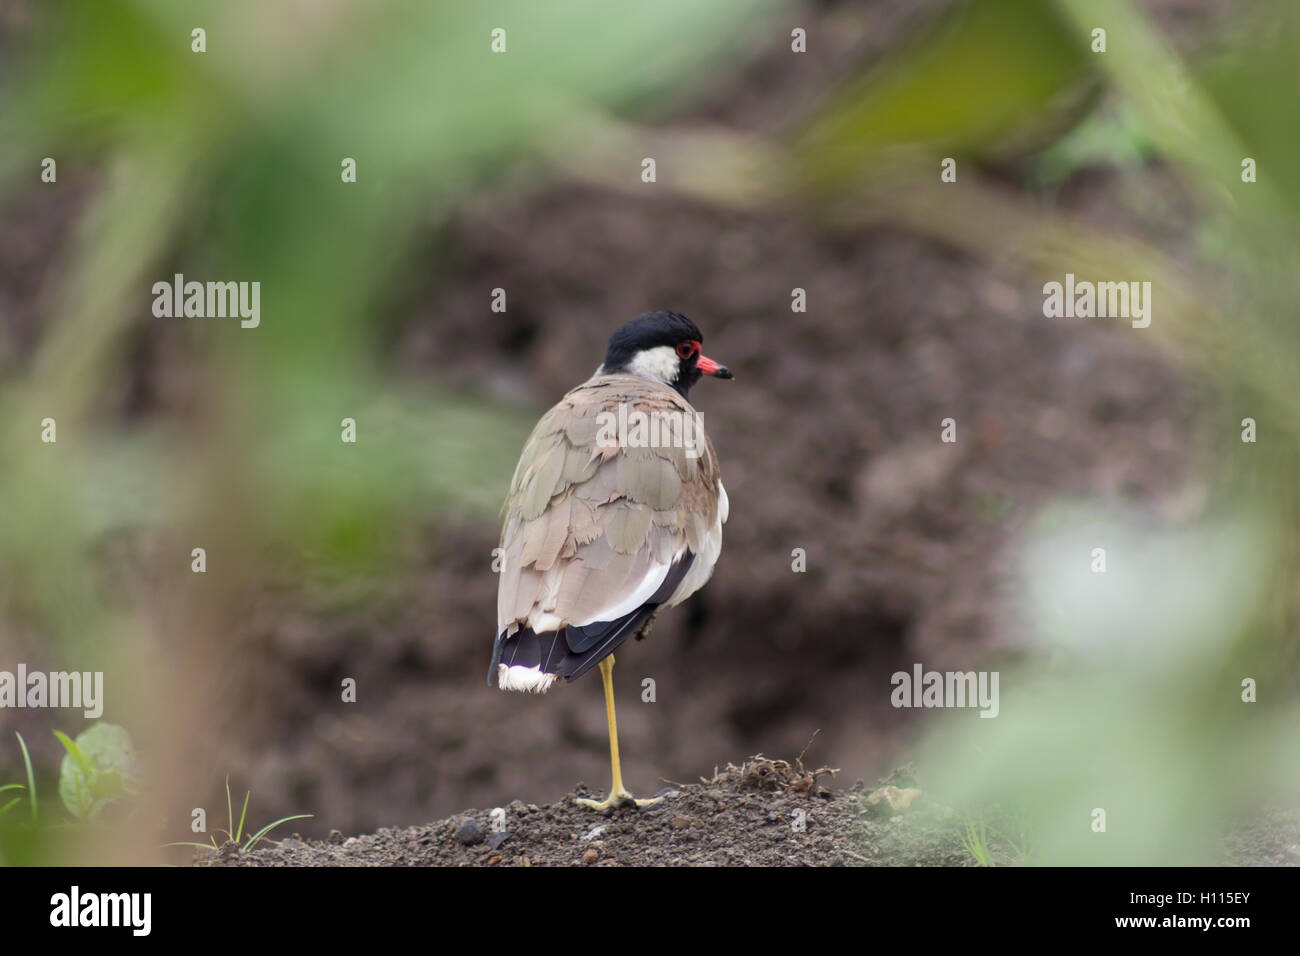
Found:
<box><xmin>601</xmin><ymin>312</ymin><xmax>733</xmax><ymax>398</ymax></box>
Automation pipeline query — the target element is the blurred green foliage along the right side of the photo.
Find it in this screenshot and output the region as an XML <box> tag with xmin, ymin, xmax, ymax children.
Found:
<box><xmin>793</xmin><ymin>0</ymin><xmax>1300</xmax><ymax>865</ymax></box>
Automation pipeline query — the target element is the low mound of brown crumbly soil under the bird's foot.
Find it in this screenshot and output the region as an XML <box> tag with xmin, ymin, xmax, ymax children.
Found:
<box><xmin>195</xmin><ymin>756</ymin><xmax>974</xmax><ymax>866</ymax></box>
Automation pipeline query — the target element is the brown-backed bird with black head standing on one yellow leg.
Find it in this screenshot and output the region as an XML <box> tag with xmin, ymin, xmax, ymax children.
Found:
<box><xmin>488</xmin><ymin>311</ymin><xmax>735</xmax><ymax>810</ymax></box>
